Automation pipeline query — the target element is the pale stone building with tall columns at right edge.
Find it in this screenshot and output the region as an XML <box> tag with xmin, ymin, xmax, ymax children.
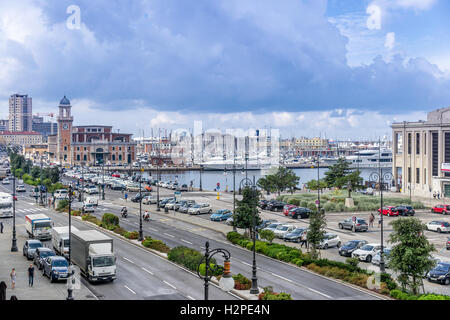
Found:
<box><xmin>391</xmin><ymin>107</ymin><xmax>450</xmax><ymax>197</ymax></box>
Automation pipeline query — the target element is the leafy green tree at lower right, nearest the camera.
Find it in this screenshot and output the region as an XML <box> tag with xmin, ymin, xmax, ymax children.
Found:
<box><xmin>389</xmin><ymin>218</ymin><xmax>435</xmax><ymax>295</ymax></box>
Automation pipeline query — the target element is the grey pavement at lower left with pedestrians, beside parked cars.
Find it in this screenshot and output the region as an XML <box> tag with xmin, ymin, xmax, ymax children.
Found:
<box><xmin>0</xmin><ymin>225</ymin><xmax>97</xmax><ymax>300</ymax></box>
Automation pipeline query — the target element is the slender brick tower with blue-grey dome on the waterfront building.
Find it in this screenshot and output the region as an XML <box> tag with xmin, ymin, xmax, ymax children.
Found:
<box><xmin>56</xmin><ymin>96</ymin><xmax>73</xmax><ymax>165</ymax></box>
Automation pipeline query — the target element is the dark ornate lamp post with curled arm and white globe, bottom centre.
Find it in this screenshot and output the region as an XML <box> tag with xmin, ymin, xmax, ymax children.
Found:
<box><xmin>197</xmin><ymin>241</ymin><xmax>234</xmax><ymax>300</ymax></box>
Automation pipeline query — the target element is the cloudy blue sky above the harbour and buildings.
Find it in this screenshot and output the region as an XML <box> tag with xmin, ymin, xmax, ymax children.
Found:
<box><xmin>0</xmin><ymin>0</ymin><xmax>450</xmax><ymax>139</ymax></box>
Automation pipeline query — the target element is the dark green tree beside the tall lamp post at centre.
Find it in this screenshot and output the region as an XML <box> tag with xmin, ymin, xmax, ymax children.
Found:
<box><xmin>233</xmin><ymin>186</ymin><xmax>261</xmax><ymax>236</ymax></box>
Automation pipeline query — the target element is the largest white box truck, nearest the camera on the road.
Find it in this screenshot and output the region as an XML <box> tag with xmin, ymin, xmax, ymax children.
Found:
<box><xmin>71</xmin><ymin>230</ymin><xmax>116</xmax><ymax>282</ymax></box>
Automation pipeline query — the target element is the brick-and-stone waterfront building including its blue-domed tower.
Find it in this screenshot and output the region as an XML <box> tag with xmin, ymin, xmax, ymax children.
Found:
<box><xmin>48</xmin><ymin>97</ymin><xmax>136</xmax><ymax>166</ymax></box>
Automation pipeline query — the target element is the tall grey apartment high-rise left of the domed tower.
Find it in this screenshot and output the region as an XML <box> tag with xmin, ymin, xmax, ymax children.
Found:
<box><xmin>9</xmin><ymin>94</ymin><xmax>33</xmax><ymax>132</ymax></box>
